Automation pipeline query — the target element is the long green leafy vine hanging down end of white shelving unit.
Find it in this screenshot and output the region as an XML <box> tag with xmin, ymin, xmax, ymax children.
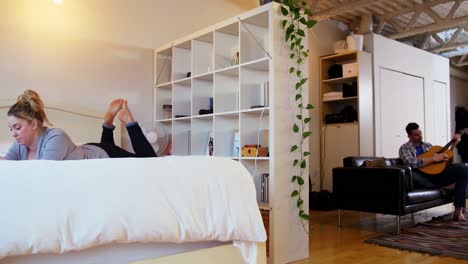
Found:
<box><xmin>281</xmin><ymin>0</ymin><xmax>317</xmax><ymax>234</ymax></box>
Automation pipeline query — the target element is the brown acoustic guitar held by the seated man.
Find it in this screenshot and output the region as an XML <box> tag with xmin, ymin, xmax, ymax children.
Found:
<box><xmin>418</xmin><ymin>128</ymin><xmax>468</xmax><ymax>175</ymax></box>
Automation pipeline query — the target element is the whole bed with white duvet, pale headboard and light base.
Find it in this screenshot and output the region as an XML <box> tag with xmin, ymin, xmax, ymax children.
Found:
<box><xmin>0</xmin><ymin>102</ymin><xmax>266</xmax><ymax>264</ymax></box>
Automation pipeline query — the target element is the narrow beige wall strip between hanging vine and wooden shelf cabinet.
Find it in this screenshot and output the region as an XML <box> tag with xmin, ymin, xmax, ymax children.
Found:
<box><xmin>309</xmin><ymin>20</ymin><xmax>348</xmax><ymax>191</ymax></box>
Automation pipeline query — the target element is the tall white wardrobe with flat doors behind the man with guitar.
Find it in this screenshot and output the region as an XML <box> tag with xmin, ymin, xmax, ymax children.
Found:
<box><xmin>365</xmin><ymin>34</ymin><xmax>452</xmax><ymax>157</ymax></box>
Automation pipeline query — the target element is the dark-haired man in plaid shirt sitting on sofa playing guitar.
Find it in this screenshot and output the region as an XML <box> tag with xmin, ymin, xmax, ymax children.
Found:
<box><xmin>399</xmin><ymin>123</ymin><xmax>468</xmax><ymax>221</ymax></box>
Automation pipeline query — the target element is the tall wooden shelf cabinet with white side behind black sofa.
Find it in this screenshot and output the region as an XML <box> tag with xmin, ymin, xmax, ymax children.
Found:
<box><xmin>319</xmin><ymin>51</ymin><xmax>374</xmax><ymax>191</ymax></box>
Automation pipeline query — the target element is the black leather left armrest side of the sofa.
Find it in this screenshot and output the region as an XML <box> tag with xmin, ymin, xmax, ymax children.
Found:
<box><xmin>333</xmin><ymin>166</ymin><xmax>410</xmax><ymax>215</ymax></box>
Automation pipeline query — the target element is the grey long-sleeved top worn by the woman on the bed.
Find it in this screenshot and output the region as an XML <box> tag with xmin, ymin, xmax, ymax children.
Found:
<box><xmin>5</xmin><ymin>127</ymin><xmax>109</xmax><ymax>160</ymax></box>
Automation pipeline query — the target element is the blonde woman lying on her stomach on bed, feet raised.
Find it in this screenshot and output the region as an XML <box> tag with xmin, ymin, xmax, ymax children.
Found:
<box><xmin>0</xmin><ymin>90</ymin><xmax>156</xmax><ymax>160</ymax></box>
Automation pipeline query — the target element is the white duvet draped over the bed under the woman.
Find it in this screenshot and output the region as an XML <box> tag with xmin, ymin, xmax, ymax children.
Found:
<box><xmin>0</xmin><ymin>156</ymin><xmax>266</xmax><ymax>263</ymax></box>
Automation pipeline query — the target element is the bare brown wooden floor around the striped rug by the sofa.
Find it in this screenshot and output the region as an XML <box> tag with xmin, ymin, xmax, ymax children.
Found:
<box><xmin>295</xmin><ymin>205</ymin><xmax>468</xmax><ymax>264</ymax></box>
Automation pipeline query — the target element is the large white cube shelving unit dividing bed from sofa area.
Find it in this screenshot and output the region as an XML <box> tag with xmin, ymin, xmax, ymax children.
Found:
<box><xmin>153</xmin><ymin>3</ymin><xmax>309</xmax><ymax>263</ymax></box>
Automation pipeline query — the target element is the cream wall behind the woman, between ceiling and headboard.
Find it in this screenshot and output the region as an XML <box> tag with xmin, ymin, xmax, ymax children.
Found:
<box><xmin>0</xmin><ymin>27</ymin><xmax>153</xmax><ymax>151</ymax></box>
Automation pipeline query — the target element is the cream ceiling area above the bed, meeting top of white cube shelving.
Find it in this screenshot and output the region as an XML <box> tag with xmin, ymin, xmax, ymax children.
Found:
<box><xmin>0</xmin><ymin>0</ymin><xmax>258</xmax><ymax>48</ymax></box>
